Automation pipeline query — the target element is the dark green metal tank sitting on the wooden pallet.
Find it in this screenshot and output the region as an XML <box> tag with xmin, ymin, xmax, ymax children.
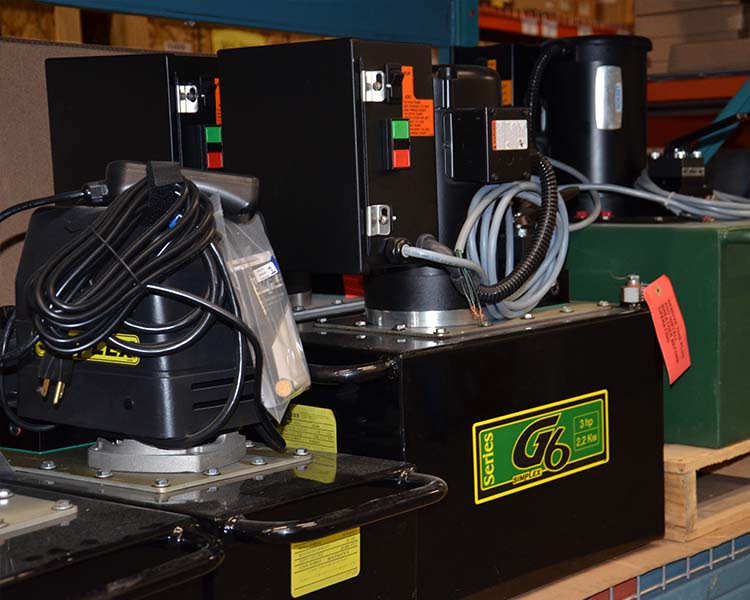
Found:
<box><xmin>568</xmin><ymin>221</ymin><xmax>750</xmax><ymax>448</ymax></box>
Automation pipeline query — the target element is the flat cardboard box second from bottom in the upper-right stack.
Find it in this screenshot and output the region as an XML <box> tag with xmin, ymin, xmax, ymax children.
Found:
<box><xmin>635</xmin><ymin>4</ymin><xmax>746</xmax><ymax>38</ymax></box>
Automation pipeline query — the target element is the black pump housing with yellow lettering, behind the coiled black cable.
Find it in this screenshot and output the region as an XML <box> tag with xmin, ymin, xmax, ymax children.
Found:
<box><xmin>16</xmin><ymin>206</ymin><xmax>267</xmax><ymax>450</ymax></box>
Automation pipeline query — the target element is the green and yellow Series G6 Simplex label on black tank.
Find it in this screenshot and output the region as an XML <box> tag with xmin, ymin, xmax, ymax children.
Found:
<box><xmin>472</xmin><ymin>390</ymin><xmax>609</xmax><ymax>504</ymax></box>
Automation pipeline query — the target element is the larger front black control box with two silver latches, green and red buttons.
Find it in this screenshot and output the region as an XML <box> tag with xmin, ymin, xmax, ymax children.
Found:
<box><xmin>219</xmin><ymin>39</ymin><xmax>437</xmax><ymax>274</ymax></box>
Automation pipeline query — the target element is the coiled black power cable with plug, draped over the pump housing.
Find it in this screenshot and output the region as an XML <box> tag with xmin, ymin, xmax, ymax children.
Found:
<box><xmin>0</xmin><ymin>173</ymin><xmax>283</xmax><ymax>448</ymax></box>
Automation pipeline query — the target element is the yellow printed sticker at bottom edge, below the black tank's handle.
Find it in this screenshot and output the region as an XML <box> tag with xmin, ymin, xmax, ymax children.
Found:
<box><xmin>291</xmin><ymin>527</ymin><xmax>360</xmax><ymax>598</ymax></box>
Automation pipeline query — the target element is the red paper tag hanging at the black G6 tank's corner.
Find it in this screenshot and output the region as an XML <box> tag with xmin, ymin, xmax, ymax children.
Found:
<box><xmin>643</xmin><ymin>275</ymin><xmax>690</xmax><ymax>385</ymax></box>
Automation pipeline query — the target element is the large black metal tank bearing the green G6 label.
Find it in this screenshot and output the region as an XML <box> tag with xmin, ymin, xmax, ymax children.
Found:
<box><xmin>298</xmin><ymin>304</ymin><xmax>664</xmax><ymax>599</ymax></box>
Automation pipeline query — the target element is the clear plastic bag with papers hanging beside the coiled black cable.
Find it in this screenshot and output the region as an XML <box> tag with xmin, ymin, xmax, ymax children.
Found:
<box><xmin>211</xmin><ymin>195</ymin><xmax>310</xmax><ymax>422</ymax></box>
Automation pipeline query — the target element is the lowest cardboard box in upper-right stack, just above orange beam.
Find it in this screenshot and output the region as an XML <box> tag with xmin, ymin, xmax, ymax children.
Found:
<box><xmin>669</xmin><ymin>38</ymin><xmax>750</xmax><ymax>73</ymax></box>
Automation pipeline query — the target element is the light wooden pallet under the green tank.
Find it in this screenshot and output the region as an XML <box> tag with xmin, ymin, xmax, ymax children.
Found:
<box><xmin>664</xmin><ymin>440</ymin><xmax>750</xmax><ymax>542</ymax></box>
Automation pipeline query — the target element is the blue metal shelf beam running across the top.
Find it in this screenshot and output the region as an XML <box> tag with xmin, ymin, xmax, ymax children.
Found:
<box><xmin>36</xmin><ymin>0</ymin><xmax>479</xmax><ymax>47</ymax></box>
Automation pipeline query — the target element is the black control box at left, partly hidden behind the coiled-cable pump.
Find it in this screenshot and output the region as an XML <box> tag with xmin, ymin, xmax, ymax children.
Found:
<box><xmin>46</xmin><ymin>54</ymin><xmax>223</xmax><ymax>192</ymax></box>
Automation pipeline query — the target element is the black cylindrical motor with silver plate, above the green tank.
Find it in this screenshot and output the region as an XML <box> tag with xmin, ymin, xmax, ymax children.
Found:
<box><xmin>541</xmin><ymin>35</ymin><xmax>660</xmax><ymax>220</ymax></box>
